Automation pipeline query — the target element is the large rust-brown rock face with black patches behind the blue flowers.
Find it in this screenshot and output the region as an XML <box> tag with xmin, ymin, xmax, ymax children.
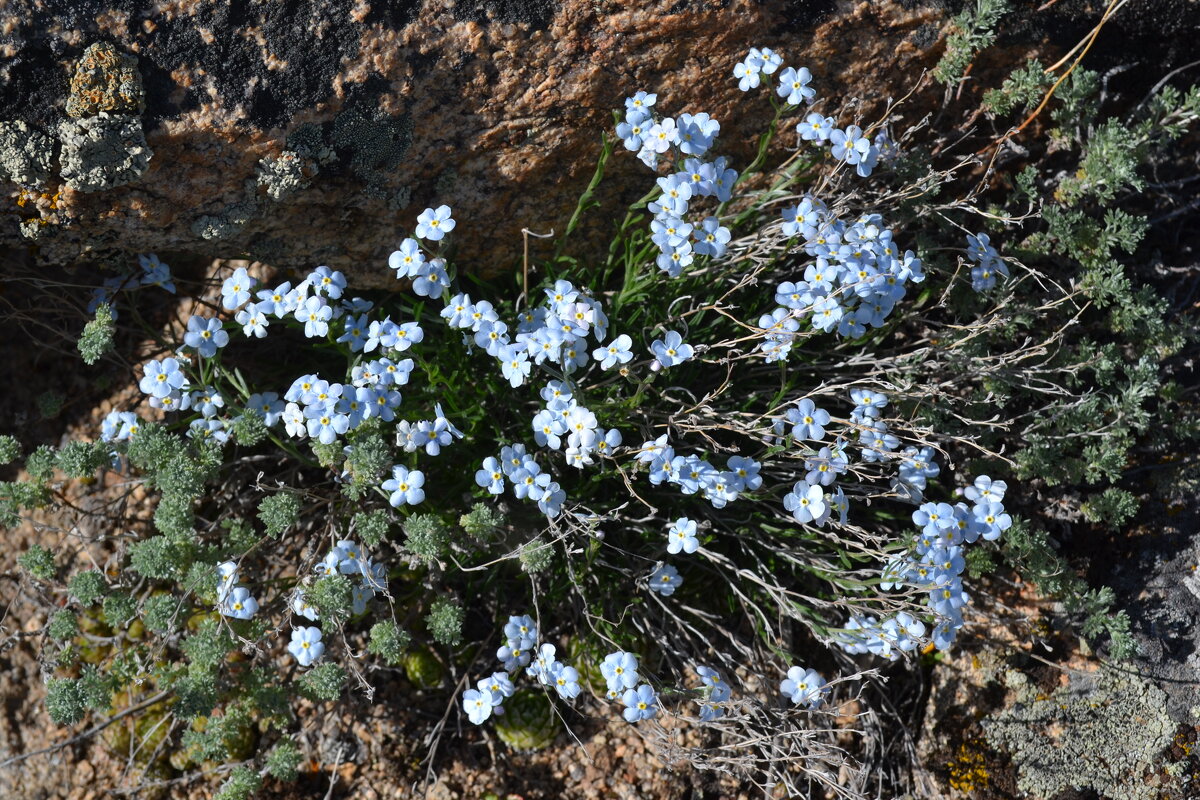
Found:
<box><xmin>0</xmin><ymin>0</ymin><xmax>1187</xmax><ymax>285</ymax></box>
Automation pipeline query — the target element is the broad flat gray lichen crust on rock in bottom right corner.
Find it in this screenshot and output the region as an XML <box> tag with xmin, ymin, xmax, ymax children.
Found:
<box><xmin>983</xmin><ymin>670</ymin><xmax>1175</xmax><ymax>800</ymax></box>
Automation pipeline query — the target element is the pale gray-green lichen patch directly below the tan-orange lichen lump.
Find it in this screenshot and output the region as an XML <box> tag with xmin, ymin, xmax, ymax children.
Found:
<box><xmin>59</xmin><ymin>112</ymin><xmax>154</xmax><ymax>192</ymax></box>
